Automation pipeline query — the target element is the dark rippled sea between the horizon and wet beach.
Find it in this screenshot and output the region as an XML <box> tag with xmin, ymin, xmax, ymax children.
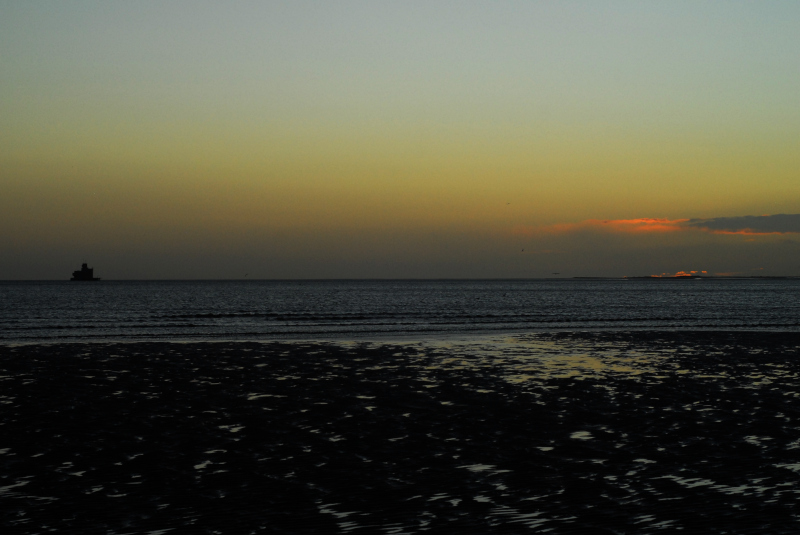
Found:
<box><xmin>0</xmin><ymin>279</ymin><xmax>800</xmax><ymax>343</ymax></box>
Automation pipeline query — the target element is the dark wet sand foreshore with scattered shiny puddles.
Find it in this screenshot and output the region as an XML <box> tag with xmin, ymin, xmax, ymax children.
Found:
<box><xmin>0</xmin><ymin>332</ymin><xmax>800</xmax><ymax>534</ymax></box>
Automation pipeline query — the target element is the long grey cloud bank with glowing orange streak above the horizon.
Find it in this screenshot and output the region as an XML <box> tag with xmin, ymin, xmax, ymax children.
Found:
<box><xmin>513</xmin><ymin>214</ymin><xmax>800</xmax><ymax>236</ymax></box>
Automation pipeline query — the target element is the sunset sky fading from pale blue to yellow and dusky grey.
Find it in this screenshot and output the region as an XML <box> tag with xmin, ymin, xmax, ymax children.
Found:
<box><xmin>0</xmin><ymin>0</ymin><xmax>800</xmax><ymax>280</ymax></box>
